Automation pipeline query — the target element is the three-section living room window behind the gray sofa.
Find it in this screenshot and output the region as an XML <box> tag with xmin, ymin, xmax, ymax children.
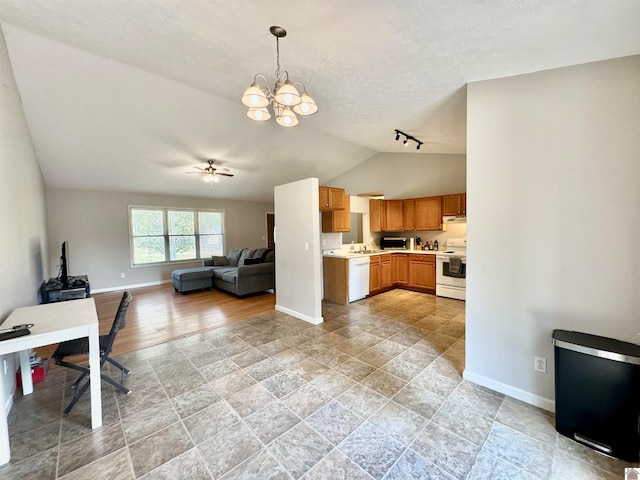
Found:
<box><xmin>129</xmin><ymin>207</ymin><xmax>224</xmax><ymax>266</ymax></box>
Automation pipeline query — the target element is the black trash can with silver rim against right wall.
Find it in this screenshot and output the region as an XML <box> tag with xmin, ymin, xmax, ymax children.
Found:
<box><xmin>552</xmin><ymin>330</ymin><xmax>640</xmax><ymax>462</ymax></box>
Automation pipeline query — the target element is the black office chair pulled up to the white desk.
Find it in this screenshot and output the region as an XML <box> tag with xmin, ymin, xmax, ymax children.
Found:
<box><xmin>52</xmin><ymin>290</ymin><xmax>133</xmax><ymax>413</ymax></box>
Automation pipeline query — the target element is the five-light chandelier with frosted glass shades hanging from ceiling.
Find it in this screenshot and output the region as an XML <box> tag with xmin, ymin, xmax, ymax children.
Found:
<box><xmin>242</xmin><ymin>26</ymin><xmax>318</xmax><ymax>127</ymax></box>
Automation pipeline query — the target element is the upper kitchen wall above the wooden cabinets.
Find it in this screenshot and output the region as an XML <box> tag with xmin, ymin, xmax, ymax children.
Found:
<box><xmin>327</xmin><ymin>153</ymin><xmax>467</xmax><ymax>199</ymax></box>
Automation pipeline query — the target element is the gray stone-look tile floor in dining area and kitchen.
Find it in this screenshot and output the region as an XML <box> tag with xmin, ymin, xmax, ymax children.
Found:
<box><xmin>0</xmin><ymin>290</ymin><xmax>630</xmax><ymax>480</ymax></box>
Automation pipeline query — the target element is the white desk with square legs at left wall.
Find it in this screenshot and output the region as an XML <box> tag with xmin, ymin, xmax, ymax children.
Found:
<box><xmin>0</xmin><ymin>298</ymin><xmax>102</xmax><ymax>465</ymax></box>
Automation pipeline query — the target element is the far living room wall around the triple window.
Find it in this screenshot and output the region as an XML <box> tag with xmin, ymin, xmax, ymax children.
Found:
<box><xmin>47</xmin><ymin>188</ymin><xmax>278</xmax><ymax>290</ymax></box>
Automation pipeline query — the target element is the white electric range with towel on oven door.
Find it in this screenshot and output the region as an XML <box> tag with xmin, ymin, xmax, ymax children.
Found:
<box><xmin>436</xmin><ymin>238</ymin><xmax>467</xmax><ymax>300</ymax></box>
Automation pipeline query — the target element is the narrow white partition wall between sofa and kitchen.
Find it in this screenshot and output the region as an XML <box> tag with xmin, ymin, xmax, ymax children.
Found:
<box><xmin>274</xmin><ymin>178</ymin><xmax>323</xmax><ymax>324</ymax></box>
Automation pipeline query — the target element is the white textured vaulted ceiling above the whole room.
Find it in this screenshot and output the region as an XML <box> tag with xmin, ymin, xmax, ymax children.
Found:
<box><xmin>0</xmin><ymin>0</ymin><xmax>640</xmax><ymax>201</ymax></box>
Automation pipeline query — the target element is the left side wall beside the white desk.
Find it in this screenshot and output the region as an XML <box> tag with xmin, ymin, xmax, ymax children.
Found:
<box><xmin>0</xmin><ymin>29</ymin><xmax>47</xmax><ymax>414</ymax></box>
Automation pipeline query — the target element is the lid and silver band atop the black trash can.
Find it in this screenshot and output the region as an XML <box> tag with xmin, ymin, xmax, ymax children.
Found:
<box><xmin>551</xmin><ymin>330</ymin><xmax>640</xmax><ymax>365</ymax></box>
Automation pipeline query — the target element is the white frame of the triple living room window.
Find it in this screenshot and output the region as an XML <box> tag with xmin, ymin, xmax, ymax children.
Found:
<box><xmin>127</xmin><ymin>205</ymin><xmax>227</xmax><ymax>268</ymax></box>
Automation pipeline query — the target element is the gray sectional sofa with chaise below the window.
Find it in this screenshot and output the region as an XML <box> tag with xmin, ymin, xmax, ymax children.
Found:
<box><xmin>171</xmin><ymin>248</ymin><xmax>276</xmax><ymax>296</ymax></box>
